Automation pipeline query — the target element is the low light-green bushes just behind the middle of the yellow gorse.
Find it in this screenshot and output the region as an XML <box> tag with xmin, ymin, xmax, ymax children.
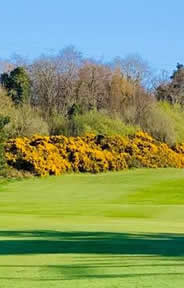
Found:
<box><xmin>49</xmin><ymin>111</ymin><xmax>138</xmax><ymax>136</ymax></box>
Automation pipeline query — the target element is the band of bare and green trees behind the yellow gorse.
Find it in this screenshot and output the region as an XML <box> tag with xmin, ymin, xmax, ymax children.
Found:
<box><xmin>0</xmin><ymin>47</ymin><xmax>184</xmax><ymax>145</ymax></box>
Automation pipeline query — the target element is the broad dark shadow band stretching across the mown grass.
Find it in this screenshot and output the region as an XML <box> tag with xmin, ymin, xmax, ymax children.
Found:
<box><xmin>0</xmin><ymin>231</ymin><xmax>184</xmax><ymax>257</ymax></box>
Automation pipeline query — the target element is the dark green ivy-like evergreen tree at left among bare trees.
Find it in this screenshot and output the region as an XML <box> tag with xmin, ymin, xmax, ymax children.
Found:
<box><xmin>1</xmin><ymin>67</ymin><xmax>30</xmax><ymax>104</ymax></box>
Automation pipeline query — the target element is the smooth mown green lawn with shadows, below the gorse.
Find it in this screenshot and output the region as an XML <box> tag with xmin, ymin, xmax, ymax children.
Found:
<box><xmin>0</xmin><ymin>169</ymin><xmax>184</xmax><ymax>288</ymax></box>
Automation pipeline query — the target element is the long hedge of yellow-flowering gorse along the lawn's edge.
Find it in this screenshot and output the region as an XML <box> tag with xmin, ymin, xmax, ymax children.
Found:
<box><xmin>5</xmin><ymin>131</ymin><xmax>184</xmax><ymax>176</ymax></box>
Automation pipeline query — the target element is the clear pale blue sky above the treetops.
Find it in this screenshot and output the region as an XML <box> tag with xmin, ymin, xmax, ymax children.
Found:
<box><xmin>0</xmin><ymin>0</ymin><xmax>184</xmax><ymax>70</ymax></box>
